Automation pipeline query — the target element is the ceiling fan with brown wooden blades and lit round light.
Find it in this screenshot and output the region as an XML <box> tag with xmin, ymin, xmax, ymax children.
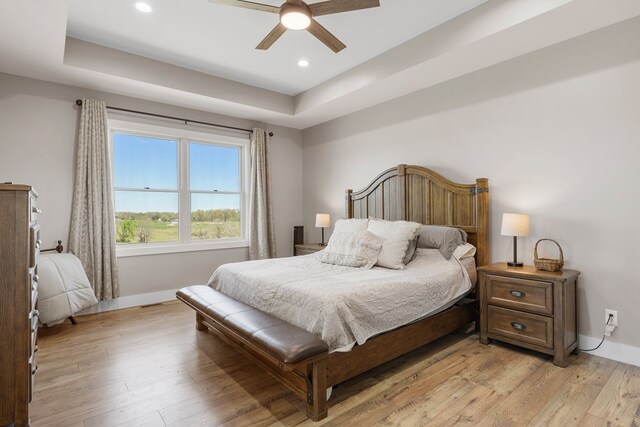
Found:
<box><xmin>209</xmin><ymin>0</ymin><xmax>380</xmax><ymax>53</ymax></box>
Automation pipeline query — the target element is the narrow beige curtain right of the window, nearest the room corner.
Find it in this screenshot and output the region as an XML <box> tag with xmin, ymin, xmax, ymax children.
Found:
<box><xmin>249</xmin><ymin>129</ymin><xmax>276</xmax><ymax>259</ymax></box>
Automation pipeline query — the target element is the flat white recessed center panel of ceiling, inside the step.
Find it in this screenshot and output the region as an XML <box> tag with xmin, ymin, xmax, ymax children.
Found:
<box><xmin>67</xmin><ymin>0</ymin><xmax>486</xmax><ymax>95</ymax></box>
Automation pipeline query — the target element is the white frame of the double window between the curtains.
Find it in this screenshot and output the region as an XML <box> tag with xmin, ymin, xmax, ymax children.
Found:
<box><xmin>109</xmin><ymin>119</ymin><xmax>251</xmax><ymax>258</ymax></box>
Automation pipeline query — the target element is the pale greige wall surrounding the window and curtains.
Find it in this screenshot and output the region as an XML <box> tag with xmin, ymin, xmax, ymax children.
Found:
<box><xmin>0</xmin><ymin>74</ymin><xmax>302</xmax><ymax>296</ymax></box>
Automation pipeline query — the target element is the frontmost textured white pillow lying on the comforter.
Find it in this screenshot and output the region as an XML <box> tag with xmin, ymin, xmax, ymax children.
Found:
<box><xmin>318</xmin><ymin>231</ymin><xmax>383</xmax><ymax>269</ymax></box>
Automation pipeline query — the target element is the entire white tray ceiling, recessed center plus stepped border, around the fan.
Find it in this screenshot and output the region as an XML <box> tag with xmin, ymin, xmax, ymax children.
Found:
<box><xmin>0</xmin><ymin>0</ymin><xmax>640</xmax><ymax>129</ymax></box>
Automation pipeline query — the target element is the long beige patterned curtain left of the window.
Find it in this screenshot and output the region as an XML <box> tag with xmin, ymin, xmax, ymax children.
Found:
<box><xmin>69</xmin><ymin>99</ymin><xmax>119</xmax><ymax>300</ymax></box>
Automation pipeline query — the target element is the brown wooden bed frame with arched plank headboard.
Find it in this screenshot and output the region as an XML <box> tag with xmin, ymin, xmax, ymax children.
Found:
<box><xmin>178</xmin><ymin>165</ymin><xmax>489</xmax><ymax>421</ymax></box>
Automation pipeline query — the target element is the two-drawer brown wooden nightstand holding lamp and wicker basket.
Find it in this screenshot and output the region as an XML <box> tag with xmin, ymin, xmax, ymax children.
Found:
<box><xmin>478</xmin><ymin>263</ymin><xmax>580</xmax><ymax>367</ymax></box>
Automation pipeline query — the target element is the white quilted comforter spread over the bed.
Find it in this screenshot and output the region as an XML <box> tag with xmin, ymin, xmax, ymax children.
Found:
<box><xmin>209</xmin><ymin>249</ymin><xmax>471</xmax><ymax>351</ymax></box>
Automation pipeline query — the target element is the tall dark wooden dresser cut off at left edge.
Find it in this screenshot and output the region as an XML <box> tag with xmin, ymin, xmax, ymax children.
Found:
<box><xmin>0</xmin><ymin>184</ymin><xmax>40</xmax><ymax>427</ymax></box>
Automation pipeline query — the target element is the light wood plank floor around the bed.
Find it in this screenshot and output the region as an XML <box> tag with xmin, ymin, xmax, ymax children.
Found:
<box><xmin>32</xmin><ymin>302</ymin><xmax>640</xmax><ymax>427</ymax></box>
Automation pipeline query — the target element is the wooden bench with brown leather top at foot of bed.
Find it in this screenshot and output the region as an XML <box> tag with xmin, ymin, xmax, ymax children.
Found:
<box><xmin>176</xmin><ymin>285</ymin><xmax>329</xmax><ymax>421</ymax></box>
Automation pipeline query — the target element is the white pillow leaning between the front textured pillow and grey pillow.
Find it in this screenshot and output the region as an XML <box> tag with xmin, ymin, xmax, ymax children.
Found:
<box><xmin>367</xmin><ymin>218</ymin><xmax>420</xmax><ymax>270</ymax></box>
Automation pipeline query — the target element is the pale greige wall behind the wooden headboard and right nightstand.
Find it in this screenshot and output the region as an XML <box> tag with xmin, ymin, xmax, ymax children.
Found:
<box><xmin>303</xmin><ymin>19</ymin><xmax>640</xmax><ymax>354</ymax></box>
